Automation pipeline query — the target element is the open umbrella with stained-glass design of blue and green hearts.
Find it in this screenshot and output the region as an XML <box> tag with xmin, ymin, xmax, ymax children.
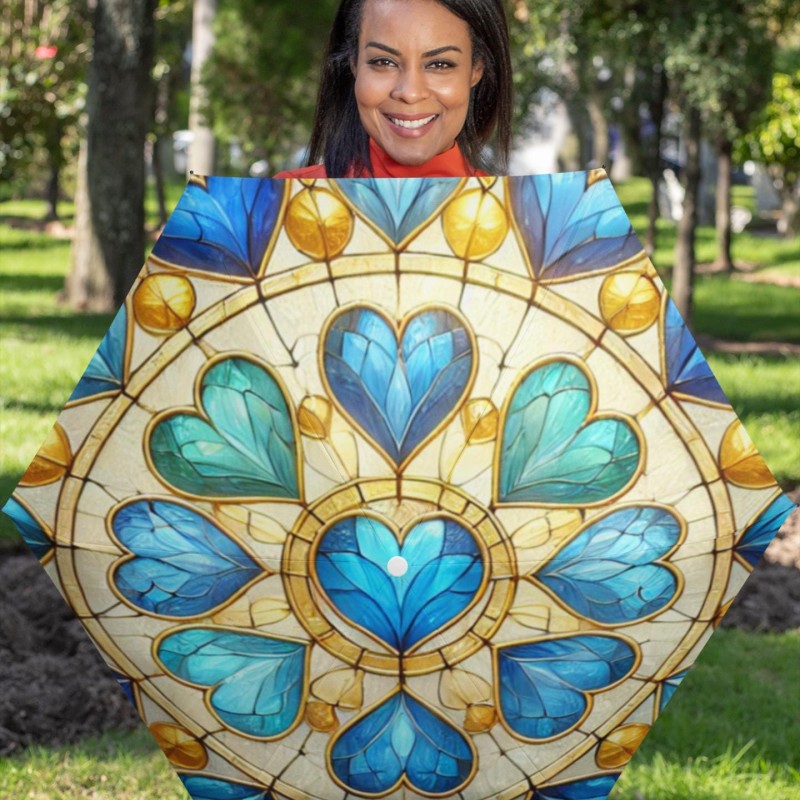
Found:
<box><xmin>5</xmin><ymin>170</ymin><xmax>793</xmax><ymax>800</ymax></box>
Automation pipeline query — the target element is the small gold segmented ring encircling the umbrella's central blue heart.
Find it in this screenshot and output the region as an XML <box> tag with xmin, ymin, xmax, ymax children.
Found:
<box><xmin>281</xmin><ymin>478</ymin><xmax>517</xmax><ymax>676</ymax></box>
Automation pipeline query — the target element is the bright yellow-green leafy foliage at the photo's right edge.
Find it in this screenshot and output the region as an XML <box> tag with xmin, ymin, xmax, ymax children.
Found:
<box><xmin>744</xmin><ymin>69</ymin><xmax>800</xmax><ymax>237</ymax></box>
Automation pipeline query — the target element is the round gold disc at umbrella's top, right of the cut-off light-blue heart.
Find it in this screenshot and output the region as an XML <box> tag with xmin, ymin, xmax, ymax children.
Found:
<box><xmin>442</xmin><ymin>189</ymin><xmax>509</xmax><ymax>261</ymax></box>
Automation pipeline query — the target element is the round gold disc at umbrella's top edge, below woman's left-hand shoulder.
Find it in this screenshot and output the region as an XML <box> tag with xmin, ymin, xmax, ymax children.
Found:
<box><xmin>284</xmin><ymin>187</ymin><xmax>353</xmax><ymax>261</ymax></box>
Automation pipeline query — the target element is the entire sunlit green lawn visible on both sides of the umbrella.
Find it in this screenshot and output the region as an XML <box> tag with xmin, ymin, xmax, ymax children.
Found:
<box><xmin>0</xmin><ymin>180</ymin><xmax>800</xmax><ymax>800</ymax></box>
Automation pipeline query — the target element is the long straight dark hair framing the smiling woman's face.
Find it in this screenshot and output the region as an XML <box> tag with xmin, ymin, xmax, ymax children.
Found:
<box><xmin>307</xmin><ymin>0</ymin><xmax>513</xmax><ymax>178</ymax></box>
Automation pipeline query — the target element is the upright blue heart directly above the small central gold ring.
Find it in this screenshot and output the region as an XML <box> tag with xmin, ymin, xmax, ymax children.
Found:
<box><xmin>323</xmin><ymin>306</ymin><xmax>475</xmax><ymax>468</ymax></box>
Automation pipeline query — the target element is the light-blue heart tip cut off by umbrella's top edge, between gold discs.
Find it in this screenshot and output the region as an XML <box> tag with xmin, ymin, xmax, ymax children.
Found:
<box><xmin>335</xmin><ymin>178</ymin><xmax>463</xmax><ymax>246</ymax></box>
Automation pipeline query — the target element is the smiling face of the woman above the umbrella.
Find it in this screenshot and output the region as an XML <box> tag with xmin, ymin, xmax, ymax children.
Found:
<box><xmin>351</xmin><ymin>0</ymin><xmax>483</xmax><ymax>166</ymax></box>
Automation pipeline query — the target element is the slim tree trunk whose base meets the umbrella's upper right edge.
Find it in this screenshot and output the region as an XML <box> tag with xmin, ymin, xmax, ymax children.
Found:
<box><xmin>671</xmin><ymin>108</ymin><xmax>700</xmax><ymax>325</ymax></box>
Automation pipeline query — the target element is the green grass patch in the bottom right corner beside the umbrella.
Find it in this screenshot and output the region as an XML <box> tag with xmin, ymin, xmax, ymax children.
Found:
<box><xmin>611</xmin><ymin>629</ymin><xmax>800</xmax><ymax>800</ymax></box>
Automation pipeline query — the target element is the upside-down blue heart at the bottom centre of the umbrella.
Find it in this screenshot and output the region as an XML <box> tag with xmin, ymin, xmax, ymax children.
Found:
<box><xmin>330</xmin><ymin>690</ymin><xmax>475</xmax><ymax>797</ymax></box>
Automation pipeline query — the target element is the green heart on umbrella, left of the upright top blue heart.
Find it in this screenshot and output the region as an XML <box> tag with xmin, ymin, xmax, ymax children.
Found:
<box><xmin>149</xmin><ymin>357</ymin><xmax>299</xmax><ymax>499</ymax></box>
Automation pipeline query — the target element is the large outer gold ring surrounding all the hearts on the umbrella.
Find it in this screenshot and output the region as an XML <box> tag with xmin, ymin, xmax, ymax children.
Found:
<box><xmin>52</xmin><ymin>178</ymin><xmax>734</xmax><ymax>800</ymax></box>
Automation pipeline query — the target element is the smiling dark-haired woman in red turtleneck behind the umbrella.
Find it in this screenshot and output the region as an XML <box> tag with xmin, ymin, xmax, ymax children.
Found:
<box><xmin>275</xmin><ymin>0</ymin><xmax>512</xmax><ymax>178</ymax></box>
